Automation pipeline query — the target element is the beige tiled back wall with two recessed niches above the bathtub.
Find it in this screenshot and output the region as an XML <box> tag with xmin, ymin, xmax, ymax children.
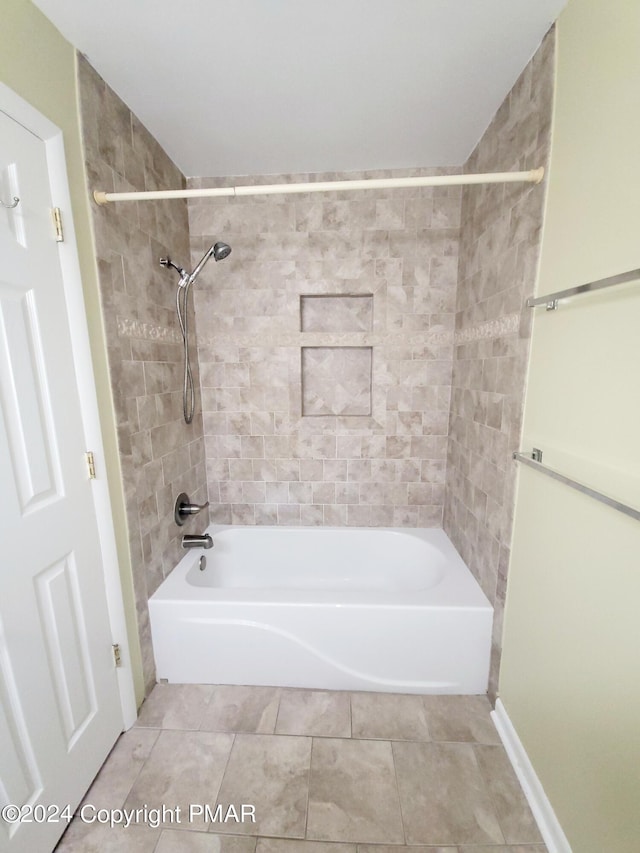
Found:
<box><xmin>189</xmin><ymin>170</ymin><xmax>461</xmax><ymax>527</ymax></box>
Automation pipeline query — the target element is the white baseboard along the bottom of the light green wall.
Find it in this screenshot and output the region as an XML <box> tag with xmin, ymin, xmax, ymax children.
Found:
<box><xmin>491</xmin><ymin>699</ymin><xmax>572</xmax><ymax>853</ymax></box>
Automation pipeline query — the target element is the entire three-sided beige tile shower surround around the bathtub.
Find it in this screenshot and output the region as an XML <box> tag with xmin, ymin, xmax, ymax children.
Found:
<box><xmin>80</xmin><ymin>31</ymin><xmax>554</xmax><ymax>694</ymax></box>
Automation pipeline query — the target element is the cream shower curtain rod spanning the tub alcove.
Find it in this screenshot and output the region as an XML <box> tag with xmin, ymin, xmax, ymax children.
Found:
<box><xmin>93</xmin><ymin>166</ymin><xmax>544</xmax><ymax>204</ymax></box>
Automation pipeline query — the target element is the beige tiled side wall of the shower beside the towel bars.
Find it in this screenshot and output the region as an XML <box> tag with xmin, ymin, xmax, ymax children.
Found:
<box><xmin>444</xmin><ymin>30</ymin><xmax>554</xmax><ymax>692</ymax></box>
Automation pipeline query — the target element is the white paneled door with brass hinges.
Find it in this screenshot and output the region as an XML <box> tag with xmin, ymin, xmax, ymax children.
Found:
<box><xmin>0</xmin><ymin>112</ymin><xmax>123</xmax><ymax>853</ymax></box>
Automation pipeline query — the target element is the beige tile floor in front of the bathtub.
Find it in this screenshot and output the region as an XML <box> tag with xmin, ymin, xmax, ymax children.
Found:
<box><xmin>56</xmin><ymin>684</ymin><xmax>546</xmax><ymax>853</ymax></box>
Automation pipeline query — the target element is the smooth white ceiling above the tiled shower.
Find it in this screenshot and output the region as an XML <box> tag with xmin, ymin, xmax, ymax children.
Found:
<box><xmin>35</xmin><ymin>0</ymin><xmax>566</xmax><ymax>176</ymax></box>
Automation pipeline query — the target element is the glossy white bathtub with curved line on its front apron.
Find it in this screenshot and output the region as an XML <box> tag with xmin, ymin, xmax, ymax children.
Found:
<box><xmin>149</xmin><ymin>525</ymin><xmax>493</xmax><ymax>693</ymax></box>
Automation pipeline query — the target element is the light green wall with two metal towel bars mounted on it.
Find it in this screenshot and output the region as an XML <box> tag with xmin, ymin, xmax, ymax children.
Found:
<box><xmin>499</xmin><ymin>0</ymin><xmax>640</xmax><ymax>853</ymax></box>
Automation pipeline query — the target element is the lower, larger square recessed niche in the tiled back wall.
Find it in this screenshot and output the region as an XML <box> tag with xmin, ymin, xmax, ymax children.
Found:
<box><xmin>302</xmin><ymin>347</ymin><xmax>372</xmax><ymax>417</ymax></box>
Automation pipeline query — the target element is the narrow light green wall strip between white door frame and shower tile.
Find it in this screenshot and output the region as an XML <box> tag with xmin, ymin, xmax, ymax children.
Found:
<box><xmin>0</xmin><ymin>0</ymin><xmax>144</xmax><ymax>704</ymax></box>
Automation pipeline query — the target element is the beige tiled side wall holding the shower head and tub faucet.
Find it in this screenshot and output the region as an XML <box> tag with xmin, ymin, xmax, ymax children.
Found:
<box><xmin>79</xmin><ymin>57</ymin><xmax>206</xmax><ymax>689</ymax></box>
